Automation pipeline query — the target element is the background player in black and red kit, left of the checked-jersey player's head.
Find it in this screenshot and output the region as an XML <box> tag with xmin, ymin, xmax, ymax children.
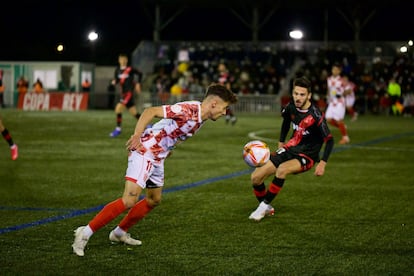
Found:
<box><xmin>109</xmin><ymin>54</ymin><xmax>142</xmax><ymax>137</ymax></box>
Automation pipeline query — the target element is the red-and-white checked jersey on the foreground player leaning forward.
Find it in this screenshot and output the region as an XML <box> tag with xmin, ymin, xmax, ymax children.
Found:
<box><xmin>138</xmin><ymin>101</ymin><xmax>203</xmax><ymax>161</ymax></box>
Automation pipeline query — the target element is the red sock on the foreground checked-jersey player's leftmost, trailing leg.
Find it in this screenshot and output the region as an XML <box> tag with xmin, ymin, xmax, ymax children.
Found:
<box><xmin>89</xmin><ymin>198</ymin><xmax>126</xmax><ymax>232</ymax></box>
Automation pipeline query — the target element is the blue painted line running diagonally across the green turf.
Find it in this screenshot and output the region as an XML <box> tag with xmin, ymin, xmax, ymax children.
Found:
<box><xmin>0</xmin><ymin>132</ymin><xmax>414</xmax><ymax>235</ymax></box>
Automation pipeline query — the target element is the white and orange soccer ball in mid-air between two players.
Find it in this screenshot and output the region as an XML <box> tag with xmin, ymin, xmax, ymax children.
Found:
<box><xmin>243</xmin><ymin>140</ymin><xmax>270</xmax><ymax>168</ymax></box>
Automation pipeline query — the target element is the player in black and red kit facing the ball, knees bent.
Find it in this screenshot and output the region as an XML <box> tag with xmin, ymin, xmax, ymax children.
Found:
<box><xmin>249</xmin><ymin>77</ymin><xmax>334</xmax><ymax>221</ymax></box>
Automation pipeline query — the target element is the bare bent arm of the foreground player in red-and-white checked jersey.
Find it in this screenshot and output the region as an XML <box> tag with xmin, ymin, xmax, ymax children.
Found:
<box><xmin>126</xmin><ymin>106</ymin><xmax>164</xmax><ymax>150</ymax></box>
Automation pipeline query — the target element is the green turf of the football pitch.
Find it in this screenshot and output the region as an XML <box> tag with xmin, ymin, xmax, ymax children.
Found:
<box><xmin>0</xmin><ymin>109</ymin><xmax>414</xmax><ymax>275</ymax></box>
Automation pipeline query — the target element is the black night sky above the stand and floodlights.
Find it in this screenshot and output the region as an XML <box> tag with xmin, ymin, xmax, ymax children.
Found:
<box><xmin>0</xmin><ymin>0</ymin><xmax>414</xmax><ymax>65</ymax></box>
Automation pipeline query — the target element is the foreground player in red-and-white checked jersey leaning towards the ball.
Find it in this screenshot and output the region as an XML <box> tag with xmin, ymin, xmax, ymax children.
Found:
<box><xmin>72</xmin><ymin>84</ymin><xmax>237</xmax><ymax>256</ymax></box>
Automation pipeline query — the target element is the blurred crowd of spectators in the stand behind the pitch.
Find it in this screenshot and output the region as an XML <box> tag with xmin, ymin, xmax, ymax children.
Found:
<box><xmin>93</xmin><ymin>39</ymin><xmax>414</xmax><ymax>114</ymax></box>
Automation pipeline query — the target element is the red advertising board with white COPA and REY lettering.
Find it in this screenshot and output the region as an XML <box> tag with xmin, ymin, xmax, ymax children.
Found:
<box><xmin>17</xmin><ymin>92</ymin><xmax>89</xmax><ymax>111</ymax></box>
